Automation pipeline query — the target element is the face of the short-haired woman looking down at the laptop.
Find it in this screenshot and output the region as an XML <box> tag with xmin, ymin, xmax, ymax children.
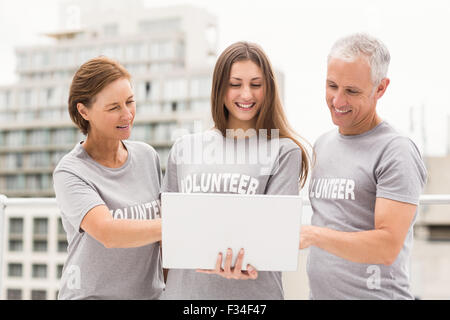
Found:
<box><xmin>78</xmin><ymin>78</ymin><xmax>136</xmax><ymax>140</ymax></box>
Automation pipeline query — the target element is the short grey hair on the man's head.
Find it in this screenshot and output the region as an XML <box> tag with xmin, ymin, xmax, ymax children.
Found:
<box><xmin>328</xmin><ymin>33</ymin><xmax>391</xmax><ymax>86</ymax></box>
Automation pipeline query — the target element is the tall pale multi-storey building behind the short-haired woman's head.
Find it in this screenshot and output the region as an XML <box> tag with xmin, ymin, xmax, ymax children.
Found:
<box><xmin>0</xmin><ymin>1</ymin><xmax>216</xmax><ymax>197</ymax></box>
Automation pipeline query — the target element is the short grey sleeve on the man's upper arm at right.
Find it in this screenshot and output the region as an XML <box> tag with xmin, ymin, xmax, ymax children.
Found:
<box><xmin>375</xmin><ymin>137</ymin><xmax>427</xmax><ymax>205</ymax></box>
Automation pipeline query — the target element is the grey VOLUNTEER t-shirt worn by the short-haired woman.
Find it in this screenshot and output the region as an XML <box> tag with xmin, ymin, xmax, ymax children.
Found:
<box><xmin>53</xmin><ymin>141</ymin><xmax>164</xmax><ymax>299</ymax></box>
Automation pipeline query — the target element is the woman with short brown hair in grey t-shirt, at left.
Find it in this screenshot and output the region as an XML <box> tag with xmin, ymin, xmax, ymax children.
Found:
<box><xmin>53</xmin><ymin>57</ymin><xmax>164</xmax><ymax>299</ymax></box>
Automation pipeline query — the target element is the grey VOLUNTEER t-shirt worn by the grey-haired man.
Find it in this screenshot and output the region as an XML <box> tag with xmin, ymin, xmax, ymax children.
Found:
<box><xmin>307</xmin><ymin>122</ymin><xmax>427</xmax><ymax>299</ymax></box>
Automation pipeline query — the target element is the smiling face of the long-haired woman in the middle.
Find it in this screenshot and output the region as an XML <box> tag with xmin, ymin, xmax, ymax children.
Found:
<box><xmin>224</xmin><ymin>60</ymin><xmax>264</xmax><ymax>130</ymax></box>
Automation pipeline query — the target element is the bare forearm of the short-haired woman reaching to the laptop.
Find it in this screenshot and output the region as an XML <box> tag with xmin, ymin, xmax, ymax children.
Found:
<box><xmin>104</xmin><ymin>219</ymin><xmax>161</xmax><ymax>248</ymax></box>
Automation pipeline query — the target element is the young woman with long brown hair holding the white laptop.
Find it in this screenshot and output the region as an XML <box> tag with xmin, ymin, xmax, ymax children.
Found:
<box><xmin>162</xmin><ymin>42</ymin><xmax>309</xmax><ymax>299</ymax></box>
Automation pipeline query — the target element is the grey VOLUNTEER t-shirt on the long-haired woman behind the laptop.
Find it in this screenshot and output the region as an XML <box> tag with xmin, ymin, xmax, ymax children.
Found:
<box><xmin>162</xmin><ymin>130</ymin><xmax>302</xmax><ymax>300</ymax></box>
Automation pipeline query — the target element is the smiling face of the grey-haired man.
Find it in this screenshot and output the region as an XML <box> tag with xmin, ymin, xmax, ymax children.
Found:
<box><xmin>326</xmin><ymin>56</ymin><xmax>389</xmax><ymax>135</ymax></box>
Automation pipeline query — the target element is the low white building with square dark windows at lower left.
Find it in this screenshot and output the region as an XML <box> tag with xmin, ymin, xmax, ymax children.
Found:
<box><xmin>1</xmin><ymin>199</ymin><xmax>63</xmax><ymax>300</ymax></box>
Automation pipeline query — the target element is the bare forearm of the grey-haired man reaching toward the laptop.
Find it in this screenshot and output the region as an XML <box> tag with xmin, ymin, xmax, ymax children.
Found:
<box><xmin>307</xmin><ymin>226</ymin><xmax>398</xmax><ymax>265</ymax></box>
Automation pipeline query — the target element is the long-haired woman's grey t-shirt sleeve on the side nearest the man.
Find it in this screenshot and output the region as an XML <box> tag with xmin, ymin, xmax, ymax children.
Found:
<box><xmin>265</xmin><ymin>148</ymin><xmax>302</xmax><ymax>195</ymax></box>
